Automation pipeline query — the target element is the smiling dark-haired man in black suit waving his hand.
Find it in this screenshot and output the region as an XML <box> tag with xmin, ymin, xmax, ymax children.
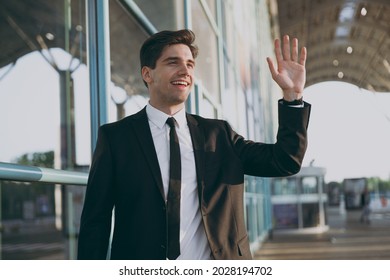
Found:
<box><xmin>78</xmin><ymin>30</ymin><xmax>310</xmax><ymax>259</ymax></box>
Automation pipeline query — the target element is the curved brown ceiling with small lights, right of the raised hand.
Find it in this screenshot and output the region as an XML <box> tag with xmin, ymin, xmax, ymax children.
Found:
<box><xmin>277</xmin><ymin>0</ymin><xmax>390</xmax><ymax>92</ymax></box>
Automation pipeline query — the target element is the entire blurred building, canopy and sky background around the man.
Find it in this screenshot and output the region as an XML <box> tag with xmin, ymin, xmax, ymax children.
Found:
<box><xmin>0</xmin><ymin>0</ymin><xmax>390</xmax><ymax>260</ymax></box>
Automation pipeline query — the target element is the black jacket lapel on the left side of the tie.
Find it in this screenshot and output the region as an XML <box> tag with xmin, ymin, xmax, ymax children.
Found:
<box><xmin>132</xmin><ymin>107</ymin><xmax>165</xmax><ymax>200</ymax></box>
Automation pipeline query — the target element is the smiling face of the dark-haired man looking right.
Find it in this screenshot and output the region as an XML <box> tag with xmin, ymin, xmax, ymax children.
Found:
<box><xmin>142</xmin><ymin>44</ymin><xmax>195</xmax><ymax>112</ymax></box>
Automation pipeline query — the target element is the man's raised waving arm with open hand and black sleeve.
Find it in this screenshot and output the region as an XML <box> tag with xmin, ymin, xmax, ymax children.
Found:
<box><xmin>227</xmin><ymin>35</ymin><xmax>311</xmax><ymax>177</ymax></box>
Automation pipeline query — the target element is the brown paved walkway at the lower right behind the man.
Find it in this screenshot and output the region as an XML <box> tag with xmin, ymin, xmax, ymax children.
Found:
<box><xmin>254</xmin><ymin>208</ymin><xmax>390</xmax><ymax>260</ymax></box>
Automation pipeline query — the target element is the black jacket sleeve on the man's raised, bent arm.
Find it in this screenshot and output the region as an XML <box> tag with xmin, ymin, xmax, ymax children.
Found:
<box><xmin>229</xmin><ymin>102</ymin><xmax>311</xmax><ymax>177</ymax></box>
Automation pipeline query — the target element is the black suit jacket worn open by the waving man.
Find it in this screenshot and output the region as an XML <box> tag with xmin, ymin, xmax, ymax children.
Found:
<box><xmin>78</xmin><ymin>103</ymin><xmax>310</xmax><ymax>259</ymax></box>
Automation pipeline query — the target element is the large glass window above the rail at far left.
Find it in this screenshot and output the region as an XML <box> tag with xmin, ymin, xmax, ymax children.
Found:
<box><xmin>0</xmin><ymin>1</ymin><xmax>90</xmax><ymax>169</ymax></box>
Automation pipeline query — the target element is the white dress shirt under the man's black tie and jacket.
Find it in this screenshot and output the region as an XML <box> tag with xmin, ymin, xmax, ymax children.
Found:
<box><xmin>146</xmin><ymin>103</ymin><xmax>211</xmax><ymax>260</ymax></box>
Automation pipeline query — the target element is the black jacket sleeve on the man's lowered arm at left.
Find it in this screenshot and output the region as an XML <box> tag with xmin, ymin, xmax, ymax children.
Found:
<box><xmin>77</xmin><ymin>126</ymin><xmax>114</xmax><ymax>260</ymax></box>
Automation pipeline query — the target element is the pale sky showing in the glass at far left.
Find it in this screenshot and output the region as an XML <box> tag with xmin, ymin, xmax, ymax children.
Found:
<box><xmin>0</xmin><ymin>52</ymin><xmax>91</xmax><ymax>165</ymax></box>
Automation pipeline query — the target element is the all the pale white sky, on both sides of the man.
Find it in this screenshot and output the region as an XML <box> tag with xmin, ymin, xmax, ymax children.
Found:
<box><xmin>0</xmin><ymin>51</ymin><xmax>390</xmax><ymax>182</ymax></box>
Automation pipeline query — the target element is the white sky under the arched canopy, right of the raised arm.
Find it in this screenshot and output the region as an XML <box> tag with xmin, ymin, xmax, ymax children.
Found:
<box><xmin>304</xmin><ymin>82</ymin><xmax>390</xmax><ymax>182</ymax></box>
